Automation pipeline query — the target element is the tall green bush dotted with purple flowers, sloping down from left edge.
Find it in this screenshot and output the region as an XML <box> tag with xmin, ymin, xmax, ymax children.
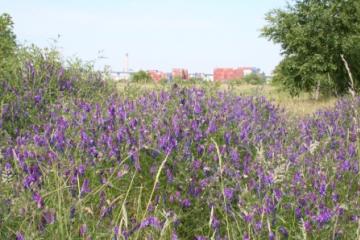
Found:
<box><xmin>0</xmin><ymin>46</ymin><xmax>115</xmax><ymax>137</ymax></box>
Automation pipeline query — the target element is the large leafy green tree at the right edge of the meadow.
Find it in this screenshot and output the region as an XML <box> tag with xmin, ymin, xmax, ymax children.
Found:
<box><xmin>262</xmin><ymin>0</ymin><xmax>360</xmax><ymax>95</ymax></box>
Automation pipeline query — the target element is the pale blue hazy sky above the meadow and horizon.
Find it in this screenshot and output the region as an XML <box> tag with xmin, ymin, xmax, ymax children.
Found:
<box><xmin>0</xmin><ymin>0</ymin><xmax>286</xmax><ymax>74</ymax></box>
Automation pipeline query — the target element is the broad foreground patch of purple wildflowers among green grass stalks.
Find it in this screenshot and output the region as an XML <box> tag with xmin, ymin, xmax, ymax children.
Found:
<box><xmin>0</xmin><ymin>88</ymin><xmax>360</xmax><ymax>239</ymax></box>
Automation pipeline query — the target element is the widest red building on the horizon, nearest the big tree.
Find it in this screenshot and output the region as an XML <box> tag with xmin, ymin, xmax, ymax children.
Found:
<box><xmin>214</xmin><ymin>67</ymin><xmax>255</xmax><ymax>82</ymax></box>
